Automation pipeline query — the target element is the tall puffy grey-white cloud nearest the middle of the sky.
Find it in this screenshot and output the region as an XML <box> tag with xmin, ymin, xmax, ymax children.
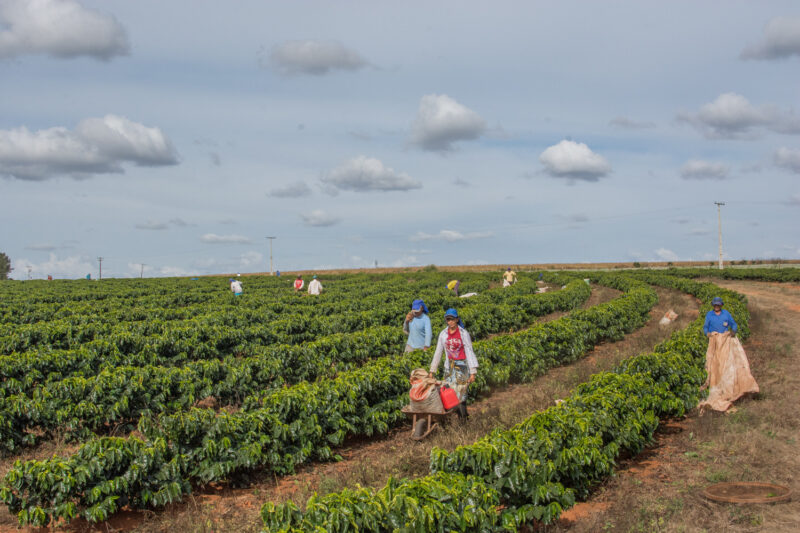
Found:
<box><xmin>411</xmin><ymin>94</ymin><xmax>486</xmax><ymax>152</ymax></box>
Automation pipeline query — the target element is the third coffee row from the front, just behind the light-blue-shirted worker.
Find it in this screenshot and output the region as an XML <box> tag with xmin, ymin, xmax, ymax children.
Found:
<box><xmin>0</xmin><ymin>274</ymin><xmax>572</xmax><ymax>451</ymax></box>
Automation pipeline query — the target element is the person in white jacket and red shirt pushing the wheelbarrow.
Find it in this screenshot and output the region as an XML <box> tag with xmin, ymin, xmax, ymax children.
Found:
<box><xmin>428</xmin><ymin>308</ymin><xmax>478</xmax><ymax>418</ymax></box>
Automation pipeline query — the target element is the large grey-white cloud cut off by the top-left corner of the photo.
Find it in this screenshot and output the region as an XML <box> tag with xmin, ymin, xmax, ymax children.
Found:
<box><xmin>0</xmin><ymin>0</ymin><xmax>130</xmax><ymax>60</ymax></box>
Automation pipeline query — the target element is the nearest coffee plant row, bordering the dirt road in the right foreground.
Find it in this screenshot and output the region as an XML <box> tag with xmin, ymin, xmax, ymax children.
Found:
<box><xmin>262</xmin><ymin>274</ymin><xmax>748</xmax><ymax>532</ymax></box>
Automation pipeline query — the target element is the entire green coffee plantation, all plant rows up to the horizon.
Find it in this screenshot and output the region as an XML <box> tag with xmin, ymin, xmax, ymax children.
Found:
<box><xmin>0</xmin><ymin>267</ymin><xmax>797</xmax><ymax>530</ymax></box>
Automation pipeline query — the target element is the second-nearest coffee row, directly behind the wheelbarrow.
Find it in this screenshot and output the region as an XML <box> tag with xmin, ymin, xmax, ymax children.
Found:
<box><xmin>0</xmin><ymin>272</ymin><xmax>655</xmax><ymax>525</ymax></box>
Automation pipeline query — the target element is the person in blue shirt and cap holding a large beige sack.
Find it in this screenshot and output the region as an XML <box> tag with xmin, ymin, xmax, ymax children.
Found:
<box><xmin>699</xmin><ymin>297</ymin><xmax>758</xmax><ymax>411</ymax></box>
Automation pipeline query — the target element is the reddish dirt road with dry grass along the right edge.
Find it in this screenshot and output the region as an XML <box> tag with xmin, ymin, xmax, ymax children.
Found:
<box><xmin>540</xmin><ymin>280</ymin><xmax>800</xmax><ymax>533</ymax></box>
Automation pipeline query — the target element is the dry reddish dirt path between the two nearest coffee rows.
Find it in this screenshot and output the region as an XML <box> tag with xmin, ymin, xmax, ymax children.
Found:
<box><xmin>0</xmin><ymin>287</ymin><xmax>699</xmax><ymax>533</ymax></box>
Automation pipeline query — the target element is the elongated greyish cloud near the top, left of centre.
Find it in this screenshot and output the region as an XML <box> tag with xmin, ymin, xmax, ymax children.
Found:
<box><xmin>269</xmin><ymin>39</ymin><xmax>368</xmax><ymax>76</ymax></box>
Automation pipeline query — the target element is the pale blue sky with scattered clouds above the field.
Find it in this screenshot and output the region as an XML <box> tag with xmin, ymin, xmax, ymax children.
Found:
<box><xmin>0</xmin><ymin>0</ymin><xmax>800</xmax><ymax>278</ymax></box>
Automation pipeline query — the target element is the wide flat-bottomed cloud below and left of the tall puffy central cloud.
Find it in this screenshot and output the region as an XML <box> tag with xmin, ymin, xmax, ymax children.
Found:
<box><xmin>321</xmin><ymin>155</ymin><xmax>422</xmax><ymax>192</ymax></box>
